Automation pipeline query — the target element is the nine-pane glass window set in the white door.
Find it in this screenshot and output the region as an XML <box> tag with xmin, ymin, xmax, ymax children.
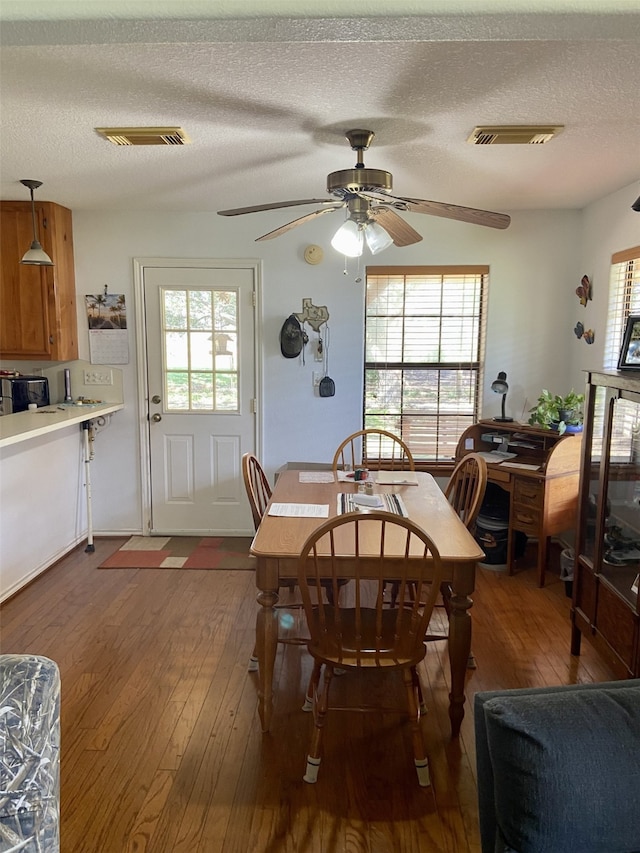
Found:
<box><xmin>161</xmin><ymin>288</ymin><xmax>239</xmax><ymax>412</ymax></box>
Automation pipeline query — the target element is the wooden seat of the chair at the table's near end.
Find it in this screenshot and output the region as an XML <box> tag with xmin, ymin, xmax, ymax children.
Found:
<box><xmin>308</xmin><ymin>607</ymin><xmax>426</xmax><ymax>669</ymax></box>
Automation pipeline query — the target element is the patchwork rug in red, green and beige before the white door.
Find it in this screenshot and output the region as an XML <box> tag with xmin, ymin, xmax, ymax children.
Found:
<box><xmin>99</xmin><ymin>536</ymin><xmax>256</xmax><ymax>571</ymax></box>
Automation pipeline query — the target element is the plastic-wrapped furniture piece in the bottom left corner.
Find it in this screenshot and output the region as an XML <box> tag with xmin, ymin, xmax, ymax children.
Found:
<box><xmin>0</xmin><ymin>655</ymin><xmax>60</xmax><ymax>853</ymax></box>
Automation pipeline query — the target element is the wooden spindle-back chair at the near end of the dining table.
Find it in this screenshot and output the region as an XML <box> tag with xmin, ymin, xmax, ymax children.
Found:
<box><xmin>298</xmin><ymin>512</ymin><xmax>442</xmax><ymax>786</ymax></box>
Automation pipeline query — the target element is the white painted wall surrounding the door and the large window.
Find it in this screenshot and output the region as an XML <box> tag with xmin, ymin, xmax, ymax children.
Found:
<box><xmin>5</xmin><ymin>187</ymin><xmax>640</xmax><ymax>534</ymax></box>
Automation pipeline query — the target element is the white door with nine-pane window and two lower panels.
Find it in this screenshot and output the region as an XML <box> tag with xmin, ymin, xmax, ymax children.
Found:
<box><xmin>142</xmin><ymin>266</ymin><xmax>256</xmax><ymax>536</ymax></box>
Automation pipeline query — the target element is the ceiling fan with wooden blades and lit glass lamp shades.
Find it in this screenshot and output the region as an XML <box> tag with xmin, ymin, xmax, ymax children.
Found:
<box><xmin>218</xmin><ymin>130</ymin><xmax>511</xmax><ymax>257</ymax></box>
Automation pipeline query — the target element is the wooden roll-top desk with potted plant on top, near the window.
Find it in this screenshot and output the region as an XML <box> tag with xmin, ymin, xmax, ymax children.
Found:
<box><xmin>456</xmin><ymin>420</ymin><xmax>582</xmax><ymax>586</ymax></box>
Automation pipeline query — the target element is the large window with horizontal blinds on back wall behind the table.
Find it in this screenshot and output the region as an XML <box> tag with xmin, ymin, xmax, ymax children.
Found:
<box><xmin>364</xmin><ymin>266</ymin><xmax>489</xmax><ymax>462</ymax></box>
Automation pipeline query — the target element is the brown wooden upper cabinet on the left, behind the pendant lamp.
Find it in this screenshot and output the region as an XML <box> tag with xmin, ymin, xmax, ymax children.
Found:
<box><xmin>0</xmin><ymin>201</ymin><xmax>78</xmax><ymax>361</ymax></box>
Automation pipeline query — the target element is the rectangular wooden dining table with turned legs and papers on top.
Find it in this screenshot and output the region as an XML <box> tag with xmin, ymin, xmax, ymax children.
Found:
<box><xmin>251</xmin><ymin>471</ymin><xmax>484</xmax><ymax>736</ymax></box>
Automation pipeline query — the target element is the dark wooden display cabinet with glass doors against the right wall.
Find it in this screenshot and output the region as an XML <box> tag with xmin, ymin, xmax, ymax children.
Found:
<box><xmin>571</xmin><ymin>371</ymin><xmax>640</xmax><ymax>678</ymax></box>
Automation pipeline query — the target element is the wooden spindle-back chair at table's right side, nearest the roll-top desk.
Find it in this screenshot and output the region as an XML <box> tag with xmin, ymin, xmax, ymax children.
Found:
<box><xmin>425</xmin><ymin>453</ymin><xmax>488</xmax><ymax>669</ymax></box>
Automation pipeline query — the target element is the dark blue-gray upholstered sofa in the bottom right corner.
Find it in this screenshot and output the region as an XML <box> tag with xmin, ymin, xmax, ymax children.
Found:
<box><xmin>474</xmin><ymin>679</ymin><xmax>640</xmax><ymax>853</ymax></box>
